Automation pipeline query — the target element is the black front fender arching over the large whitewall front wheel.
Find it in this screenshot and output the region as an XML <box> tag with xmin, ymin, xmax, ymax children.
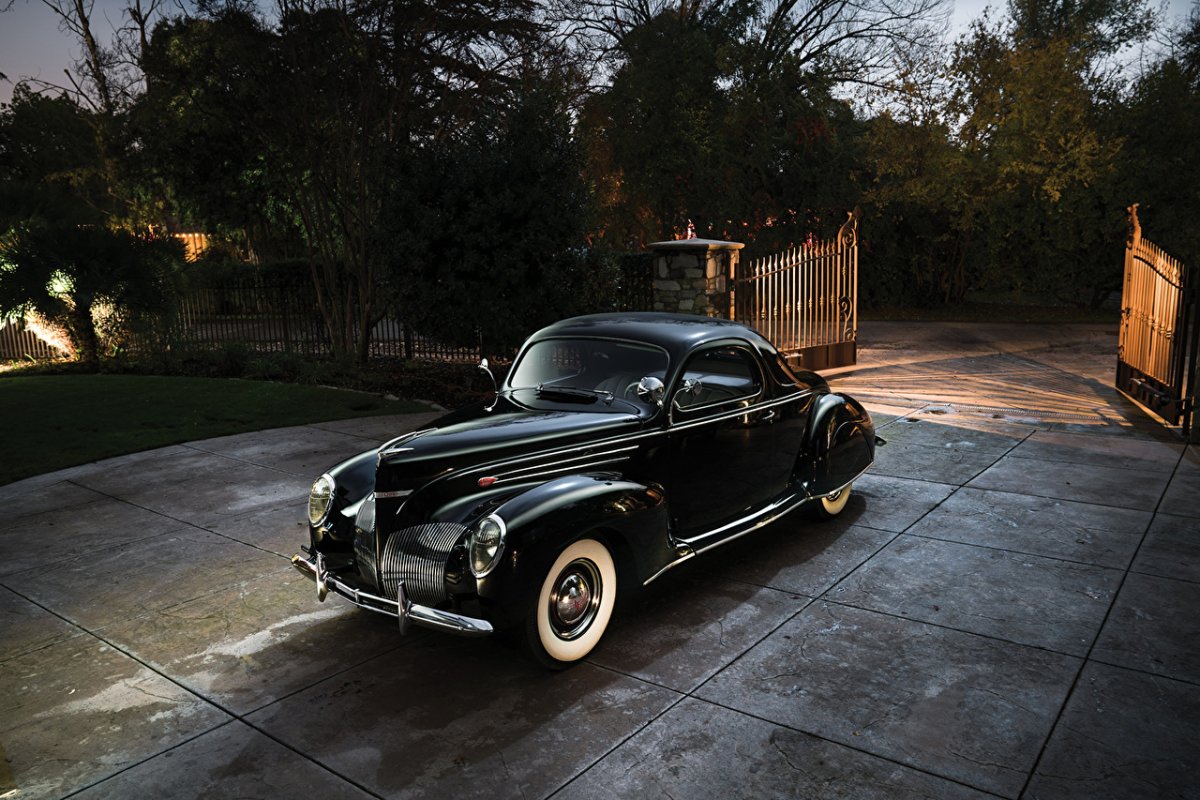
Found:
<box><xmin>478</xmin><ymin>473</ymin><xmax>674</xmax><ymax>624</ymax></box>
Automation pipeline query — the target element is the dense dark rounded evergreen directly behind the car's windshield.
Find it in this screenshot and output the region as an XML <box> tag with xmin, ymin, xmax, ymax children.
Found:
<box><xmin>382</xmin><ymin>74</ymin><xmax>610</xmax><ymax>353</ymax></box>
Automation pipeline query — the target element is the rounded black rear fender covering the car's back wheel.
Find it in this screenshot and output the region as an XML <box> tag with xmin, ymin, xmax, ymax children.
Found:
<box><xmin>797</xmin><ymin>393</ymin><xmax>875</xmax><ymax>497</ymax></box>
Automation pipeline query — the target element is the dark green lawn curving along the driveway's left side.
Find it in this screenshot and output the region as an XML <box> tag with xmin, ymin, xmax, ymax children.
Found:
<box><xmin>0</xmin><ymin>375</ymin><xmax>430</xmax><ymax>485</ymax></box>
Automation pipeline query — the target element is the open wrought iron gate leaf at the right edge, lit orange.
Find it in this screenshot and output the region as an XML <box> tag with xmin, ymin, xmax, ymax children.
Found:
<box><xmin>1117</xmin><ymin>204</ymin><xmax>1200</xmax><ymax>437</ymax></box>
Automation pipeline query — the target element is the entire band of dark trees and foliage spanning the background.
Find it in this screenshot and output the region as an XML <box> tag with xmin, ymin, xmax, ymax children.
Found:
<box><xmin>0</xmin><ymin>0</ymin><xmax>1200</xmax><ymax>360</ymax></box>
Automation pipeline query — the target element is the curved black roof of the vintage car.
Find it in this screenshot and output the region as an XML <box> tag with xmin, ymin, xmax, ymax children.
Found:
<box><xmin>529</xmin><ymin>312</ymin><xmax>774</xmax><ymax>359</ymax></box>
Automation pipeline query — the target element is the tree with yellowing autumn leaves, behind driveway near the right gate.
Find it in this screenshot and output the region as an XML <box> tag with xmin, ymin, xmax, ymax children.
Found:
<box><xmin>948</xmin><ymin>17</ymin><xmax>1123</xmax><ymax>305</ymax></box>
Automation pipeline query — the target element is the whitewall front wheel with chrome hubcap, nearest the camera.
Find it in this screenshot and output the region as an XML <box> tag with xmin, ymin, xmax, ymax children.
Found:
<box><xmin>526</xmin><ymin>539</ymin><xmax>617</xmax><ymax>669</ymax></box>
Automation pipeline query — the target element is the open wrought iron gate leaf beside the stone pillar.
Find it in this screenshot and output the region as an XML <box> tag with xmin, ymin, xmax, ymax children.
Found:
<box><xmin>730</xmin><ymin>209</ymin><xmax>858</xmax><ymax>369</ymax></box>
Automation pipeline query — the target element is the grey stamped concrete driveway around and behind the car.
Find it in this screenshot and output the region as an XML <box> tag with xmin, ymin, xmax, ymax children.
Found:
<box><xmin>0</xmin><ymin>324</ymin><xmax>1200</xmax><ymax>800</ymax></box>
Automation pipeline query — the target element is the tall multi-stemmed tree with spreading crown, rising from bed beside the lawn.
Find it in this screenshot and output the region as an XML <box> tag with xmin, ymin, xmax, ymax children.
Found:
<box><xmin>135</xmin><ymin>0</ymin><xmax>538</xmax><ymax>361</ymax></box>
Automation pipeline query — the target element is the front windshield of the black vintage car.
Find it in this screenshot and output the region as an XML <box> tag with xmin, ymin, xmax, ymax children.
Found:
<box><xmin>509</xmin><ymin>339</ymin><xmax>667</xmax><ymax>403</ymax></box>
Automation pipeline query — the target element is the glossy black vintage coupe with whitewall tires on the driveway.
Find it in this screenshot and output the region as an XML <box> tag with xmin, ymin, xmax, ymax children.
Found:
<box><xmin>292</xmin><ymin>313</ymin><xmax>875</xmax><ymax>667</ymax></box>
